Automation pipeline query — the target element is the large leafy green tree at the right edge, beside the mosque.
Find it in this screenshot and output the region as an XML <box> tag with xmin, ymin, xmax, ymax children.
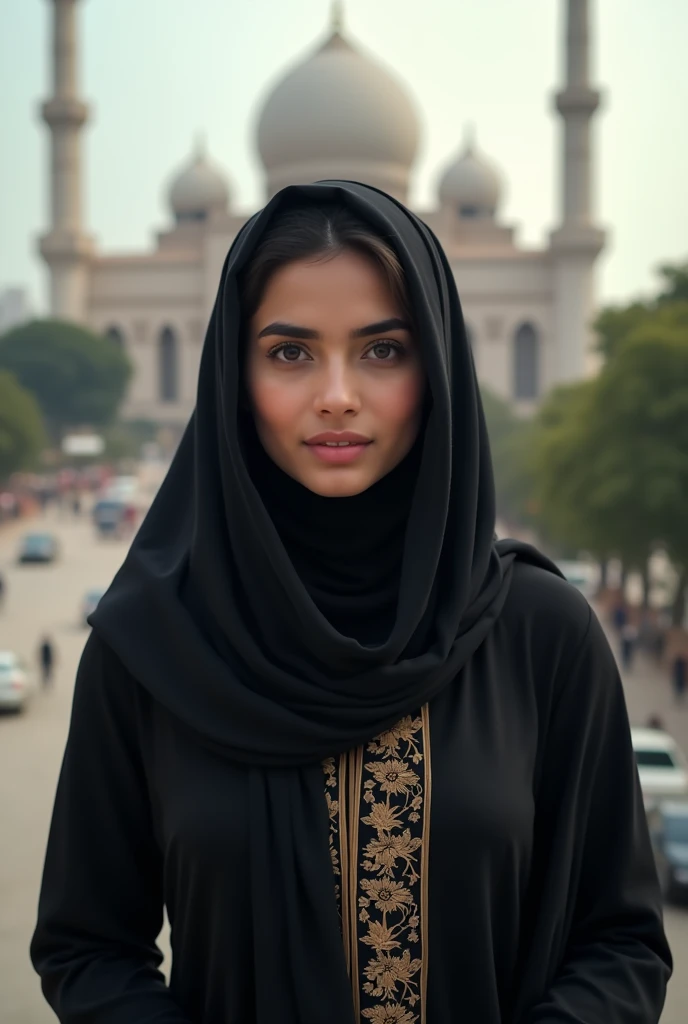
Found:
<box><xmin>535</xmin><ymin>302</ymin><xmax>688</xmax><ymax>620</ymax></box>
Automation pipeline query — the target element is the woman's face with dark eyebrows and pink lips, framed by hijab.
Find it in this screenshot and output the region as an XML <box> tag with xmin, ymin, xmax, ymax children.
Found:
<box><xmin>247</xmin><ymin>250</ymin><xmax>425</xmax><ymax>498</ymax></box>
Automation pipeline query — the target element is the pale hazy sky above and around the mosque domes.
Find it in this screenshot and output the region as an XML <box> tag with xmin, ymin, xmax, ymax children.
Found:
<box><xmin>0</xmin><ymin>0</ymin><xmax>688</xmax><ymax>309</ymax></box>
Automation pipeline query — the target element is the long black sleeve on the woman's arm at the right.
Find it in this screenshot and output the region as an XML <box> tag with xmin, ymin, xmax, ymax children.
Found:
<box><xmin>519</xmin><ymin>615</ymin><xmax>672</xmax><ymax>1024</ymax></box>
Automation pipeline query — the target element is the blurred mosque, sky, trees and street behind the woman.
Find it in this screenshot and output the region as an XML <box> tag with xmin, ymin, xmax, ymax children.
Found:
<box><xmin>0</xmin><ymin>0</ymin><xmax>688</xmax><ymax>1024</ymax></box>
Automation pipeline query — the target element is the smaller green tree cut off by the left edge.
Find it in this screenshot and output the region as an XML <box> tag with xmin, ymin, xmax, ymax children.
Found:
<box><xmin>0</xmin><ymin>371</ymin><xmax>45</xmax><ymax>481</ymax></box>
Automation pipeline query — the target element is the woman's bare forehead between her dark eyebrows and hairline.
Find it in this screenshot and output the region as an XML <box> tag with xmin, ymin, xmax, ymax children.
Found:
<box><xmin>256</xmin><ymin>251</ymin><xmax>401</xmax><ymax>321</ymax></box>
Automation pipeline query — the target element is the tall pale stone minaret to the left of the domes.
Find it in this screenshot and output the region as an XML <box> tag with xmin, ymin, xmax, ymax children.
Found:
<box><xmin>40</xmin><ymin>0</ymin><xmax>92</xmax><ymax>322</ymax></box>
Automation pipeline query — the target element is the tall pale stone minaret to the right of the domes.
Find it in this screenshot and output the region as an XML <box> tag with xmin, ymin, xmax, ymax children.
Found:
<box><xmin>551</xmin><ymin>0</ymin><xmax>604</xmax><ymax>383</ymax></box>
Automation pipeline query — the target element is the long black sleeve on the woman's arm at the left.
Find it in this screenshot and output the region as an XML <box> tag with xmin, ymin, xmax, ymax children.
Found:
<box><xmin>31</xmin><ymin>636</ymin><xmax>188</xmax><ymax>1024</ymax></box>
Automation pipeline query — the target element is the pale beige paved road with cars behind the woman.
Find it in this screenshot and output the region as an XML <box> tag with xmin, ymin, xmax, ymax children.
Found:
<box><xmin>0</xmin><ymin>520</ymin><xmax>688</xmax><ymax>1024</ymax></box>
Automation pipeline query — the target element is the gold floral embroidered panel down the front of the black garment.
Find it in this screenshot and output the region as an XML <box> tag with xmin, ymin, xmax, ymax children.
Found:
<box><xmin>324</xmin><ymin>706</ymin><xmax>431</xmax><ymax>1024</ymax></box>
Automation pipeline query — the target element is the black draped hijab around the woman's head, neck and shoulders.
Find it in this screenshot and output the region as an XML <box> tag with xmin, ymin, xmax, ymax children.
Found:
<box><xmin>91</xmin><ymin>181</ymin><xmax>552</xmax><ymax>1024</ymax></box>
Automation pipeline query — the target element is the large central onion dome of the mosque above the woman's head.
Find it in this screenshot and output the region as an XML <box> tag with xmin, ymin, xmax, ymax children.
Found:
<box><xmin>258</xmin><ymin>13</ymin><xmax>420</xmax><ymax>200</ymax></box>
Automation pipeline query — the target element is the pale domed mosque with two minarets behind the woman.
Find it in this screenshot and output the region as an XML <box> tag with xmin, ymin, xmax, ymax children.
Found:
<box><xmin>40</xmin><ymin>0</ymin><xmax>604</xmax><ymax>428</ymax></box>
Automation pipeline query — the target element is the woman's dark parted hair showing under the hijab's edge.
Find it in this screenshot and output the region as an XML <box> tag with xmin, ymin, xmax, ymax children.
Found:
<box><xmin>240</xmin><ymin>203</ymin><xmax>413</xmax><ymax>323</ymax></box>
